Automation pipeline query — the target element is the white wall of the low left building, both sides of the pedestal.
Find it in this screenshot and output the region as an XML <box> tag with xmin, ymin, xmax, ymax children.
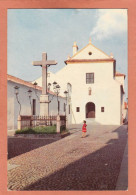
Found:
<box><xmin>7</xmin><ymin>81</ymin><xmax>65</xmax><ymax>130</ymax></box>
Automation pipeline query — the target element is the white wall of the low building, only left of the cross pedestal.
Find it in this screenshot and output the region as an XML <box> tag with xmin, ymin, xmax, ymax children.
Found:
<box><xmin>7</xmin><ymin>81</ymin><xmax>41</xmax><ymax>129</ymax></box>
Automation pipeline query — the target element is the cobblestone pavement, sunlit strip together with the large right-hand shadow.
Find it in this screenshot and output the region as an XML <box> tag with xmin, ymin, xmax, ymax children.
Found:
<box><xmin>8</xmin><ymin>125</ymin><xmax>127</xmax><ymax>191</ymax></box>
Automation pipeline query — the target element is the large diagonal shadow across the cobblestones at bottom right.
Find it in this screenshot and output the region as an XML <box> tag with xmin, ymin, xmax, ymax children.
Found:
<box><xmin>23</xmin><ymin>127</ymin><xmax>127</xmax><ymax>190</ymax></box>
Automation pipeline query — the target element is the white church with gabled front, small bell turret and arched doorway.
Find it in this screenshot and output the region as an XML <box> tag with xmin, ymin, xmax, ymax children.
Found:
<box><xmin>36</xmin><ymin>41</ymin><xmax>125</xmax><ymax>125</ymax></box>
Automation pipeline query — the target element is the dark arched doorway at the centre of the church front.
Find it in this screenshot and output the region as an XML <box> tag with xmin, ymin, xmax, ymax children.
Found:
<box><xmin>86</xmin><ymin>102</ymin><xmax>95</xmax><ymax>118</ymax></box>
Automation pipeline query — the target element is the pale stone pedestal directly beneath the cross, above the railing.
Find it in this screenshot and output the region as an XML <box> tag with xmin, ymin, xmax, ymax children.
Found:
<box><xmin>40</xmin><ymin>95</ymin><xmax>49</xmax><ymax>116</ymax></box>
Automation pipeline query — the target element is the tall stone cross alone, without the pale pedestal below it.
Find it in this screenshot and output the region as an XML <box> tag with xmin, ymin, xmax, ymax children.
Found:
<box><xmin>33</xmin><ymin>52</ymin><xmax>57</xmax><ymax>95</ymax></box>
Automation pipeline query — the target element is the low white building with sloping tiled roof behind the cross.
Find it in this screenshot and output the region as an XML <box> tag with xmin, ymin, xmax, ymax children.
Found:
<box><xmin>7</xmin><ymin>75</ymin><xmax>66</xmax><ymax>130</ymax></box>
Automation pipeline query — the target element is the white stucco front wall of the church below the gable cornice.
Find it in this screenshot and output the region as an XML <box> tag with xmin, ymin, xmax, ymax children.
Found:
<box><xmin>48</xmin><ymin>62</ymin><xmax>121</xmax><ymax>125</ymax></box>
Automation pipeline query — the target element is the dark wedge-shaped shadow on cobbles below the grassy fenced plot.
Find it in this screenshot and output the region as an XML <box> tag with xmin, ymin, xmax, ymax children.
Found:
<box><xmin>8</xmin><ymin>137</ymin><xmax>57</xmax><ymax>159</ymax></box>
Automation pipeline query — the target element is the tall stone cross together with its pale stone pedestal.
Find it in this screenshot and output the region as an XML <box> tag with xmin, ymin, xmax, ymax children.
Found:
<box><xmin>33</xmin><ymin>52</ymin><xmax>57</xmax><ymax>116</ymax></box>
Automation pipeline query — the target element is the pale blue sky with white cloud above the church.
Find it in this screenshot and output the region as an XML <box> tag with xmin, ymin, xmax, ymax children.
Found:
<box><xmin>8</xmin><ymin>9</ymin><xmax>128</xmax><ymax>97</ymax></box>
